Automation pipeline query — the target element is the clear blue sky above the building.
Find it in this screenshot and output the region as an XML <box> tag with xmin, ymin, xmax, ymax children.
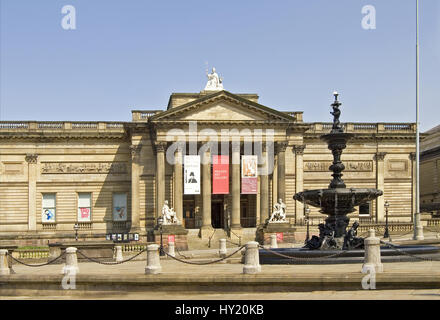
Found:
<box><xmin>0</xmin><ymin>0</ymin><xmax>440</xmax><ymax>131</ymax></box>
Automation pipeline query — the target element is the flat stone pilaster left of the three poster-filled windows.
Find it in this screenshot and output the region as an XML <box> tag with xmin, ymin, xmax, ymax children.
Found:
<box><xmin>25</xmin><ymin>154</ymin><xmax>38</xmax><ymax>231</ymax></box>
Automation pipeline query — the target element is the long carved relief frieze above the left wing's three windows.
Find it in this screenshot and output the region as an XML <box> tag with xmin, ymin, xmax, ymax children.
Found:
<box><xmin>41</xmin><ymin>162</ymin><xmax>127</xmax><ymax>174</ymax></box>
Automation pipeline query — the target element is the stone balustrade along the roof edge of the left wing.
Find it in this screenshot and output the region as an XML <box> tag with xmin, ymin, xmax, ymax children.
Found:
<box><xmin>0</xmin><ymin>121</ymin><xmax>124</xmax><ymax>133</ymax></box>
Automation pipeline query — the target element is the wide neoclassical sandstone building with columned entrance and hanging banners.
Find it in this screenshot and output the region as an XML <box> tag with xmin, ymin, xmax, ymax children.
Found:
<box><xmin>0</xmin><ymin>75</ymin><xmax>415</xmax><ymax>242</ymax></box>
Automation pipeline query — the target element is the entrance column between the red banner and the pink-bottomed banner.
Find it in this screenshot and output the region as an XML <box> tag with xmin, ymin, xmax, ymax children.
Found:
<box><xmin>231</xmin><ymin>143</ymin><xmax>241</xmax><ymax>229</ymax></box>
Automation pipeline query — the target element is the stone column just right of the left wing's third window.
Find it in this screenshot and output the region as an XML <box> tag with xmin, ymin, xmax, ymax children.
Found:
<box><xmin>130</xmin><ymin>144</ymin><xmax>142</xmax><ymax>232</ymax></box>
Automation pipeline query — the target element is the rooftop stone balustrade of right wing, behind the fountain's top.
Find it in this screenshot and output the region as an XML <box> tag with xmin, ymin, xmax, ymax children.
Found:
<box><xmin>307</xmin><ymin>122</ymin><xmax>416</xmax><ymax>134</ymax></box>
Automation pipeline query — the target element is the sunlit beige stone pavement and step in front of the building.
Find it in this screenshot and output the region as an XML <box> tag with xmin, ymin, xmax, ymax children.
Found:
<box><xmin>0</xmin><ymin>234</ymin><xmax>440</xmax><ymax>300</ymax></box>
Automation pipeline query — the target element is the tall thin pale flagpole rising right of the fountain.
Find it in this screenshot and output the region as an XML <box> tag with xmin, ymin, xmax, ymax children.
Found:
<box><xmin>414</xmin><ymin>0</ymin><xmax>424</xmax><ymax>240</ymax></box>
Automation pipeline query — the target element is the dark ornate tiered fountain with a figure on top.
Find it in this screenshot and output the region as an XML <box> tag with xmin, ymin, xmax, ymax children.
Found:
<box><xmin>293</xmin><ymin>92</ymin><xmax>383</xmax><ymax>250</ymax></box>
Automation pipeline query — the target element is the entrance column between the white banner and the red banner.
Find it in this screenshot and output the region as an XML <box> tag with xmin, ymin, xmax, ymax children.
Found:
<box><xmin>200</xmin><ymin>148</ymin><xmax>213</xmax><ymax>239</ymax></box>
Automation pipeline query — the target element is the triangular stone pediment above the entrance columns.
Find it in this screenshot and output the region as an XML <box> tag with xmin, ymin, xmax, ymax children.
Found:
<box><xmin>150</xmin><ymin>91</ymin><xmax>294</xmax><ymax>123</ymax></box>
